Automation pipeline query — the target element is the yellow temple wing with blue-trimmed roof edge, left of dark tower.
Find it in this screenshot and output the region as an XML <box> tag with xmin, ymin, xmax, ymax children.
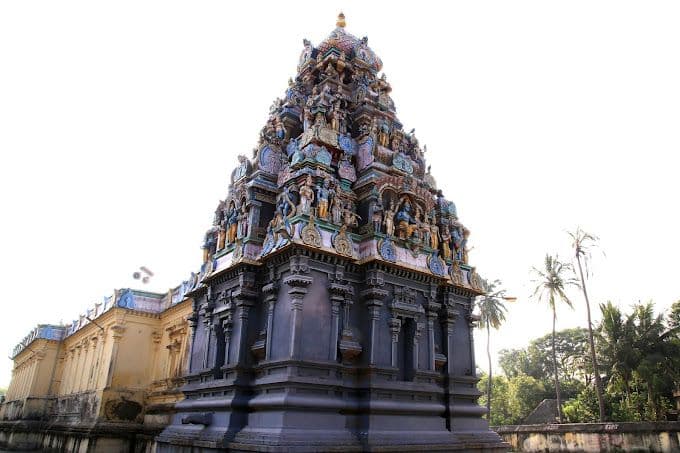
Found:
<box><xmin>0</xmin><ymin>282</ymin><xmax>195</xmax><ymax>424</ymax></box>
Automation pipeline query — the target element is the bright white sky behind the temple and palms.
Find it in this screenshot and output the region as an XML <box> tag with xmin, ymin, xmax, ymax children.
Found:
<box><xmin>0</xmin><ymin>0</ymin><xmax>680</xmax><ymax>386</ymax></box>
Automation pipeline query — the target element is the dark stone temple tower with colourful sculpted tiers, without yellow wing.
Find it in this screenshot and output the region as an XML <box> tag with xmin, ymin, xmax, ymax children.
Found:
<box><xmin>156</xmin><ymin>14</ymin><xmax>507</xmax><ymax>452</ymax></box>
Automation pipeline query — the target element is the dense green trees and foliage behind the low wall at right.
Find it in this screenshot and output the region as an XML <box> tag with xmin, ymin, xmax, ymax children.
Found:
<box><xmin>479</xmin><ymin>301</ymin><xmax>680</xmax><ymax>425</ymax></box>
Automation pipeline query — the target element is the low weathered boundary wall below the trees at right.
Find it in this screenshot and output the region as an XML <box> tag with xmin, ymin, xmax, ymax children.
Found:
<box><xmin>496</xmin><ymin>422</ymin><xmax>680</xmax><ymax>453</ymax></box>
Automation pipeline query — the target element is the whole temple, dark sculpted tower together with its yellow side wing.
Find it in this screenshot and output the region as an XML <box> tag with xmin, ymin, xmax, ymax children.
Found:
<box><xmin>0</xmin><ymin>14</ymin><xmax>508</xmax><ymax>453</ymax></box>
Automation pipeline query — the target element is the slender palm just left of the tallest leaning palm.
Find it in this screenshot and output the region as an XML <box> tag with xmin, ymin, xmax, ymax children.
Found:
<box><xmin>532</xmin><ymin>255</ymin><xmax>576</xmax><ymax>423</ymax></box>
